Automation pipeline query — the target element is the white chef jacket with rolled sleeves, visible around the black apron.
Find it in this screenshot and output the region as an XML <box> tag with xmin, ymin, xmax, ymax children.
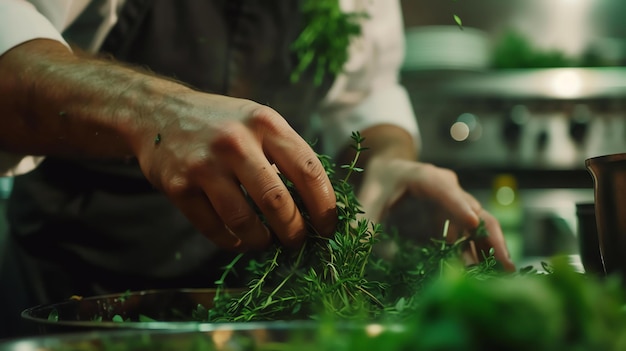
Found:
<box><xmin>0</xmin><ymin>0</ymin><xmax>420</xmax><ymax>176</ymax></box>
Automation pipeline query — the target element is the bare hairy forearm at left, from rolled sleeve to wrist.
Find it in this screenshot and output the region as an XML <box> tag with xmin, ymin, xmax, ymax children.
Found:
<box><xmin>0</xmin><ymin>40</ymin><xmax>188</xmax><ymax>158</ymax></box>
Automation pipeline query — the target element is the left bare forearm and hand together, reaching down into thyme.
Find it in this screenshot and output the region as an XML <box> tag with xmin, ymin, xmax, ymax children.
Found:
<box><xmin>0</xmin><ymin>39</ymin><xmax>337</xmax><ymax>251</ymax></box>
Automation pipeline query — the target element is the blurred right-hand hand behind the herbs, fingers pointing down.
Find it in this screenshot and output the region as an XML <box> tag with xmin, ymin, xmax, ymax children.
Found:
<box><xmin>359</xmin><ymin>157</ymin><xmax>515</xmax><ymax>271</ymax></box>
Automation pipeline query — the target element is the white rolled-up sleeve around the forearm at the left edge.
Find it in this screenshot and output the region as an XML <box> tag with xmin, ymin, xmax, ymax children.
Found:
<box><xmin>0</xmin><ymin>0</ymin><xmax>67</xmax><ymax>176</ymax></box>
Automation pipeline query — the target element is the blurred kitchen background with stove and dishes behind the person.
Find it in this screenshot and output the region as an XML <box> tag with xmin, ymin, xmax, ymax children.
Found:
<box><xmin>0</xmin><ymin>0</ymin><xmax>626</xmax><ymax>270</ymax></box>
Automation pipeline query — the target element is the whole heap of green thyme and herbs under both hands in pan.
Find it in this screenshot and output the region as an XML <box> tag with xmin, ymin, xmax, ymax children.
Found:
<box><xmin>205</xmin><ymin>132</ymin><xmax>508</xmax><ymax>322</ymax></box>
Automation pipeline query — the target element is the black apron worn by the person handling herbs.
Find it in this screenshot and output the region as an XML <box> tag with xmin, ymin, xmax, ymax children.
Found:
<box><xmin>0</xmin><ymin>0</ymin><xmax>332</xmax><ymax>336</ymax></box>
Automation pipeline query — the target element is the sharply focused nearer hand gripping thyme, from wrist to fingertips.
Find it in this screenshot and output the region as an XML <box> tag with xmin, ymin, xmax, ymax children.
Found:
<box><xmin>134</xmin><ymin>94</ymin><xmax>337</xmax><ymax>251</ymax></box>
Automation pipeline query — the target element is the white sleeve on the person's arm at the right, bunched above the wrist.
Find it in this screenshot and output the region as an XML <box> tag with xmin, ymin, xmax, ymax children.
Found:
<box><xmin>320</xmin><ymin>0</ymin><xmax>420</xmax><ymax>156</ymax></box>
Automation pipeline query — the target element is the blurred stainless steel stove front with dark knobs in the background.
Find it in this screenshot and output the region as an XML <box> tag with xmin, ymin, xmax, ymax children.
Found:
<box><xmin>403</xmin><ymin>68</ymin><xmax>626</xmax><ymax>172</ymax></box>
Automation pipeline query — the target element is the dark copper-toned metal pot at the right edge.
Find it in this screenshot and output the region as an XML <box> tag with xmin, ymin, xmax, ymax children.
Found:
<box><xmin>586</xmin><ymin>153</ymin><xmax>626</xmax><ymax>278</ymax></box>
